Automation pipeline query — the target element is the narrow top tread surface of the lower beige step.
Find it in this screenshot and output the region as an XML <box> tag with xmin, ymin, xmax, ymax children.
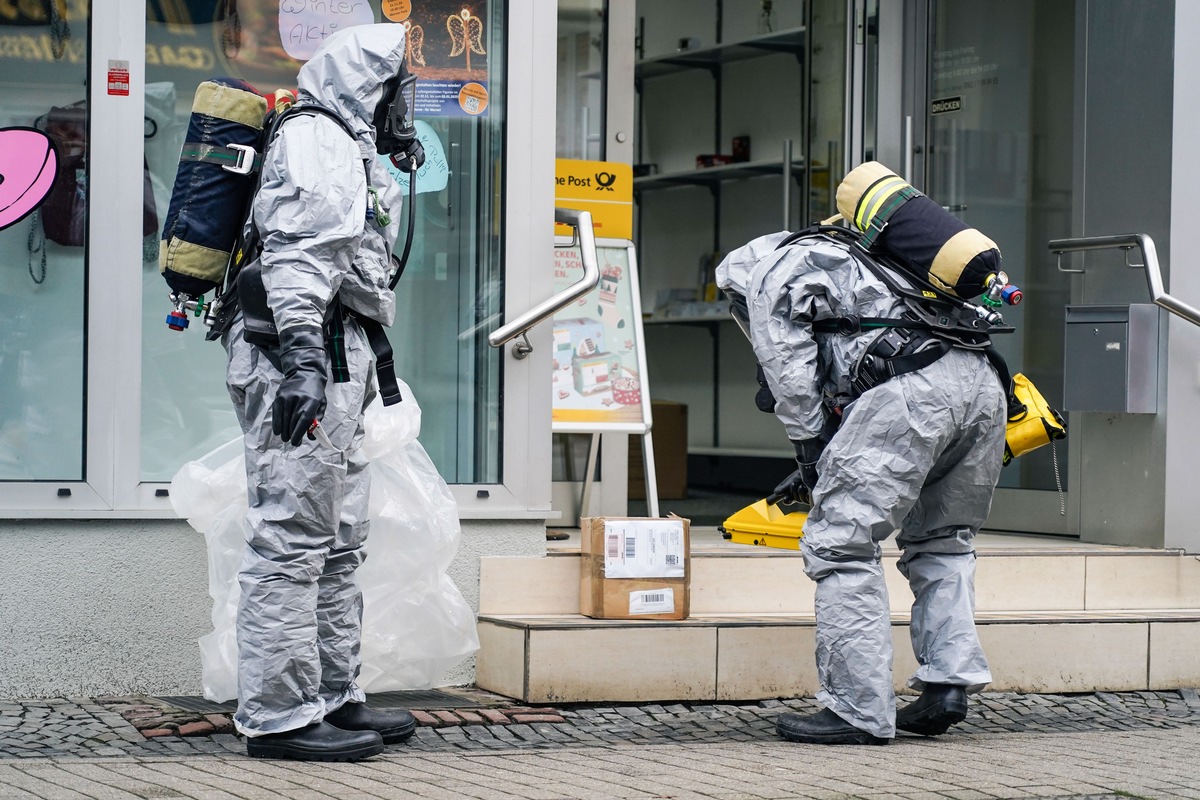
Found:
<box><xmin>476</xmin><ymin>608</ymin><xmax>1200</xmax><ymax>631</ymax></box>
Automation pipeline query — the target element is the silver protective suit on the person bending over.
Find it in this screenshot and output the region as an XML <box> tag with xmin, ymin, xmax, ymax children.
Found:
<box><xmin>716</xmin><ymin>233</ymin><xmax>1007</xmax><ymax>738</ymax></box>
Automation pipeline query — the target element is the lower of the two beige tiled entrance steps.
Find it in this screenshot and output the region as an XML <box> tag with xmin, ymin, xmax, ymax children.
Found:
<box><xmin>475</xmin><ymin>609</ymin><xmax>1200</xmax><ymax>703</ymax></box>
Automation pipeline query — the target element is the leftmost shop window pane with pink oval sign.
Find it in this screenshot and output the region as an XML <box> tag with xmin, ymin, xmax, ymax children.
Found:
<box><xmin>0</xmin><ymin>0</ymin><xmax>91</xmax><ymax>481</ymax></box>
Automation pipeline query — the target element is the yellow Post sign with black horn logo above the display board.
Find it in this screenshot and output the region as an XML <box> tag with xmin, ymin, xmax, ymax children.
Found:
<box><xmin>554</xmin><ymin>158</ymin><xmax>634</xmax><ymax>239</ymax></box>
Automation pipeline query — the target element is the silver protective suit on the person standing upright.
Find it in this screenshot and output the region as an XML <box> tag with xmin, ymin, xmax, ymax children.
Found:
<box><xmin>223</xmin><ymin>24</ymin><xmax>404</xmax><ymax>736</ymax></box>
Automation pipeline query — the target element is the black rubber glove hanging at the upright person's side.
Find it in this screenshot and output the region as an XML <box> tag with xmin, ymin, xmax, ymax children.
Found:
<box><xmin>271</xmin><ymin>326</ymin><xmax>329</xmax><ymax>446</ymax></box>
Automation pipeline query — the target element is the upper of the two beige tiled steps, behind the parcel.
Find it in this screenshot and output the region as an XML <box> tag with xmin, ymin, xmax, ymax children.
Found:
<box><xmin>479</xmin><ymin>529</ymin><xmax>1200</xmax><ymax>616</ymax></box>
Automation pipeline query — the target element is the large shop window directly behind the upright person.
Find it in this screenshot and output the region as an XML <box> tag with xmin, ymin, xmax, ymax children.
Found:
<box><xmin>142</xmin><ymin>0</ymin><xmax>506</xmax><ymax>483</ymax></box>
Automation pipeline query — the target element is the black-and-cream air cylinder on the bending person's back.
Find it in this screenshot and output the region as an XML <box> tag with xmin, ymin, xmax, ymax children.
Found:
<box><xmin>838</xmin><ymin>161</ymin><xmax>1001</xmax><ymax>297</ymax></box>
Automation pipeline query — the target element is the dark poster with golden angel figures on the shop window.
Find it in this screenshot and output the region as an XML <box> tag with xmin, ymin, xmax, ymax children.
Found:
<box><xmin>382</xmin><ymin>0</ymin><xmax>503</xmax><ymax>116</ymax></box>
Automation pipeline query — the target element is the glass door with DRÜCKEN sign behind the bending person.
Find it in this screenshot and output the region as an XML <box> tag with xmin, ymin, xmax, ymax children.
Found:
<box><xmin>910</xmin><ymin>0</ymin><xmax>1075</xmax><ymax>533</ymax></box>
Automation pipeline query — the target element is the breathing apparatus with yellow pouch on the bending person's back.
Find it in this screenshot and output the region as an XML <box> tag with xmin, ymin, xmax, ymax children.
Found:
<box><xmin>763</xmin><ymin>162</ymin><xmax>1067</xmax><ymax>465</ymax></box>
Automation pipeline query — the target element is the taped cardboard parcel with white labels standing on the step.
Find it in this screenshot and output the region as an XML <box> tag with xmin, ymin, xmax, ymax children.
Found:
<box><xmin>580</xmin><ymin>517</ymin><xmax>691</xmax><ymax>619</ymax></box>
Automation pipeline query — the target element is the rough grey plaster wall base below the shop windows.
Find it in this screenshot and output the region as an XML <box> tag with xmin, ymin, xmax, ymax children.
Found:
<box><xmin>0</xmin><ymin>519</ymin><xmax>546</xmax><ymax>698</ymax></box>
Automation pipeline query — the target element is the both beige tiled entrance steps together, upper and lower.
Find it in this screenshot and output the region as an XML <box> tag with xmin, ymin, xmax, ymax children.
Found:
<box><xmin>476</xmin><ymin>529</ymin><xmax>1200</xmax><ymax>703</ymax></box>
